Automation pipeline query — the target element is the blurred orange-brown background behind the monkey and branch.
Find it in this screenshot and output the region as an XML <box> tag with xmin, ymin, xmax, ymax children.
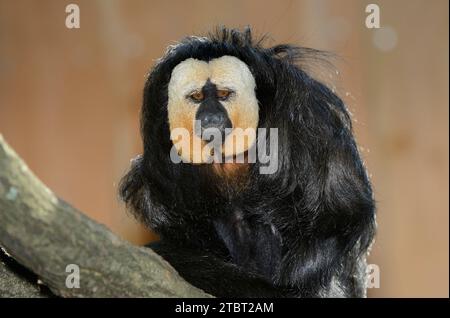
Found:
<box><xmin>0</xmin><ymin>0</ymin><xmax>449</xmax><ymax>297</ymax></box>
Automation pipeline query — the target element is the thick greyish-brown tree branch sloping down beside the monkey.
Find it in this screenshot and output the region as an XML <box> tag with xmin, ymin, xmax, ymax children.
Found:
<box><xmin>0</xmin><ymin>135</ymin><xmax>209</xmax><ymax>297</ymax></box>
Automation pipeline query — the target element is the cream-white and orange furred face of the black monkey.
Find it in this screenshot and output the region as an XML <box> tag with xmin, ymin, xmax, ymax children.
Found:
<box><xmin>167</xmin><ymin>55</ymin><xmax>259</xmax><ymax>163</ymax></box>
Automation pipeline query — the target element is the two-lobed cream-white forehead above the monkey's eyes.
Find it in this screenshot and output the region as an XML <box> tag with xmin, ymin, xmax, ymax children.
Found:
<box><xmin>169</xmin><ymin>55</ymin><xmax>256</xmax><ymax>93</ymax></box>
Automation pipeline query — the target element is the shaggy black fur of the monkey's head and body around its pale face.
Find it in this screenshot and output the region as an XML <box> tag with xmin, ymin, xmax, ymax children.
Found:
<box><xmin>120</xmin><ymin>29</ymin><xmax>375</xmax><ymax>297</ymax></box>
